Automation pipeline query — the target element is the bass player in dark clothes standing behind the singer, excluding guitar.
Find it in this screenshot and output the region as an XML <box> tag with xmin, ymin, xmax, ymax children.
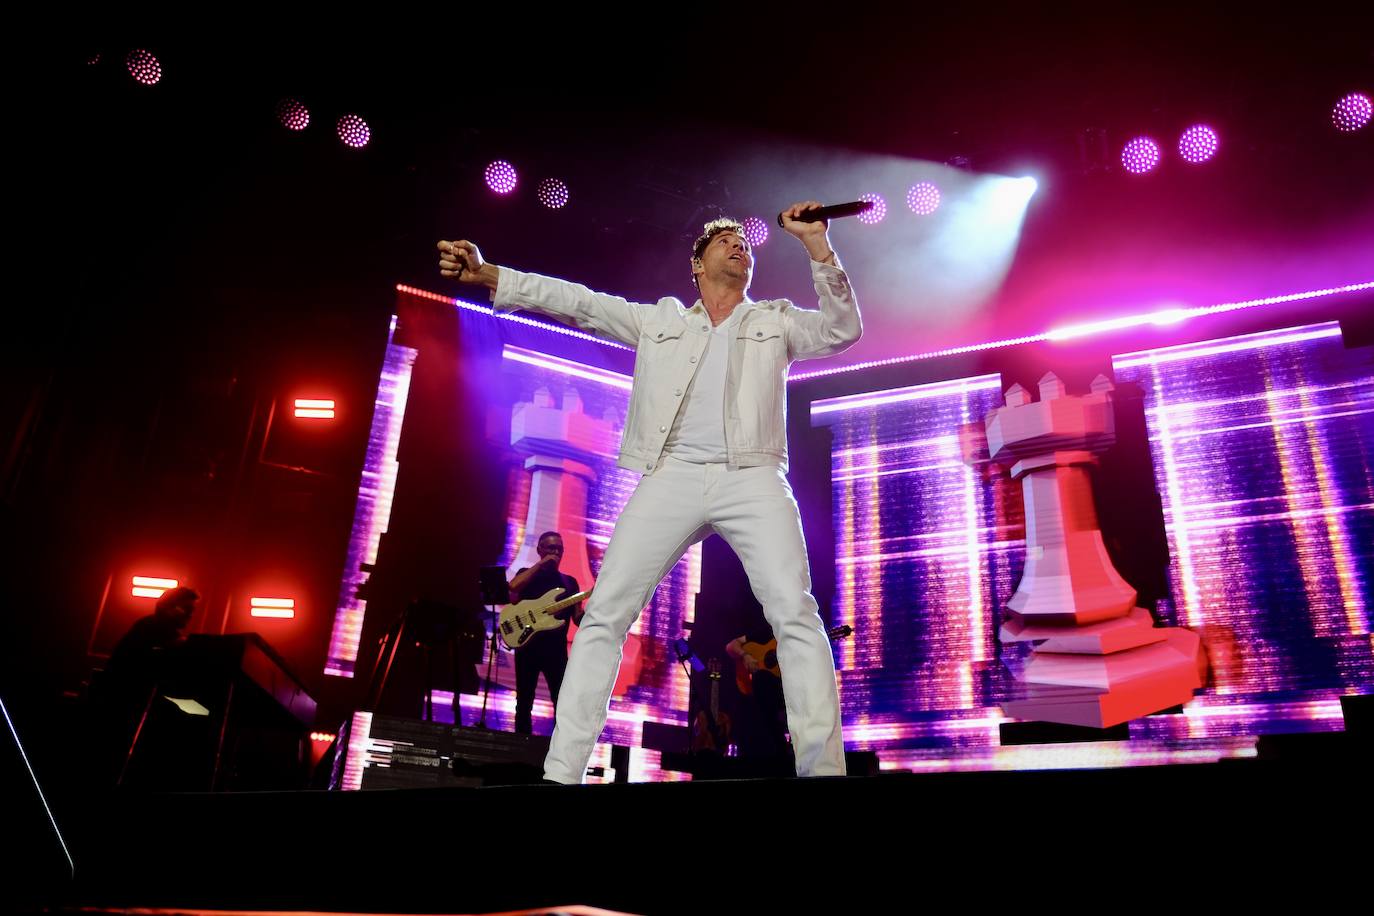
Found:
<box><xmin>510</xmin><ymin>531</ymin><xmax>583</xmax><ymax>735</ymax></box>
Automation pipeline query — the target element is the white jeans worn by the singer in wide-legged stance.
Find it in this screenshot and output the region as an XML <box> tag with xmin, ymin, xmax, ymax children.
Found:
<box><xmin>544</xmin><ymin>457</ymin><xmax>845</xmax><ymax>783</ymax></box>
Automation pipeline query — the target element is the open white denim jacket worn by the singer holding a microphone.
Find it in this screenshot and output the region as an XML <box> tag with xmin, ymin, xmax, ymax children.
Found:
<box><xmin>493</xmin><ymin>255</ymin><xmax>863</xmax><ymax>474</ymax></box>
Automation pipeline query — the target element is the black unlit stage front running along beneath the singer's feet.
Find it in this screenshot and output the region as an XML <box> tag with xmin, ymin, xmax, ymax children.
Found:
<box><xmin>21</xmin><ymin>735</ymin><xmax>1374</xmax><ymax>913</ymax></box>
